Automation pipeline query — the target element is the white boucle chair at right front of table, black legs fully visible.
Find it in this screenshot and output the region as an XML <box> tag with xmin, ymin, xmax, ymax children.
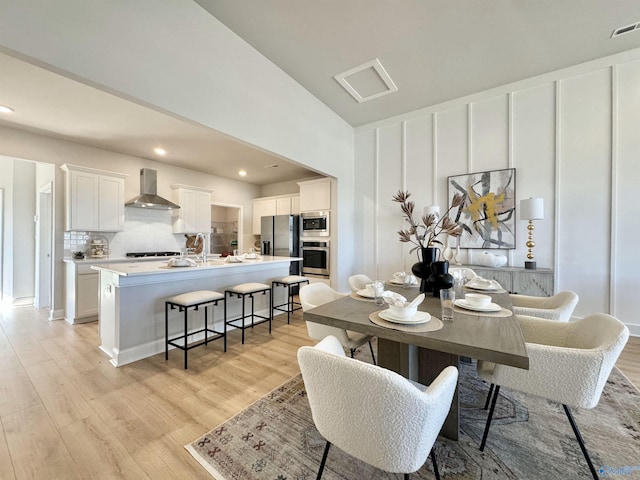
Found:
<box><xmin>478</xmin><ymin>313</ymin><xmax>629</xmax><ymax>479</ymax></box>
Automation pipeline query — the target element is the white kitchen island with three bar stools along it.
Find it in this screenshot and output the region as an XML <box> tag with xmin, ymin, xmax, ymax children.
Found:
<box><xmin>91</xmin><ymin>256</ymin><xmax>302</xmax><ymax>367</ymax></box>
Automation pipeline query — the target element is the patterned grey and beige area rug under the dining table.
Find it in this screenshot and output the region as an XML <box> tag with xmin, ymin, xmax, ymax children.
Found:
<box><xmin>185</xmin><ymin>363</ymin><xmax>640</xmax><ymax>480</ymax></box>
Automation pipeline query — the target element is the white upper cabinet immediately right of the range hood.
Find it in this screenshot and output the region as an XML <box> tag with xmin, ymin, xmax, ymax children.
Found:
<box><xmin>171</xmin><ymin>184</ymin><xmax>213</xmax><ymax>234</ymax></box>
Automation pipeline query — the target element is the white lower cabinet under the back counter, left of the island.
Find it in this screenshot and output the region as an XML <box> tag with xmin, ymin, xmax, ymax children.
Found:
<box><xmin>64</xmin><ymin>262</ymin><xmax>99</xmax><ymax>323</ymax></box>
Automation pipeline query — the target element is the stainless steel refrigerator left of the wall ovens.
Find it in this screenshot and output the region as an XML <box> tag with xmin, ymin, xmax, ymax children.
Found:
<box><xmin>260</xmin><ymin>215</ymin><xmax>300</xmax><ymax>275</ymax></box>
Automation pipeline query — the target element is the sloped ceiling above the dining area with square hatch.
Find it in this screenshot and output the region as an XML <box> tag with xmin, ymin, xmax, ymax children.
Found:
<box><xmin>196</xmin><ymin>0</ymin><xmax>640</xmax><ymax>126</ymax></box>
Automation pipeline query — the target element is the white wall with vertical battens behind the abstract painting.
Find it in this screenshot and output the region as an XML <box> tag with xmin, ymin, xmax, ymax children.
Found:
<box><xmin>355</xmin><ymin>50</ymin><xmax>640</xmax><ymax>335</ymax></box>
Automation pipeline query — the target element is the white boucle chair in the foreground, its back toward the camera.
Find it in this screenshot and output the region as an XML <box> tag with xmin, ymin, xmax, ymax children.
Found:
<box><xmin>298</xmin><ymin>336</ymin><xmax>458</xmax><ymax>480</ymax></box>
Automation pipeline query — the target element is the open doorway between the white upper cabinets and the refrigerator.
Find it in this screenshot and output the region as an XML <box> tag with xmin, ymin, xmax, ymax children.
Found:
<box><xmin>209</xmin><ymin>203</ymin><xmax>244</xmax><ymax>255</ymax></box>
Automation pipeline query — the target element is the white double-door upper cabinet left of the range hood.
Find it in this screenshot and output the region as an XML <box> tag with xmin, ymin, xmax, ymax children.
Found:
<box><xmin>60</xmin><ymin>164</ymin><xmax>127</xmax><ymax>232</ymax></box>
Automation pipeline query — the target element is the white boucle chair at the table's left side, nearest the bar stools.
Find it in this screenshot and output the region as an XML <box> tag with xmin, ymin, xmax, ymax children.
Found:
<box><xmin>298</xmin><ymin>283</ymin><xmax>376</xmax><ymax>365</ymax></box>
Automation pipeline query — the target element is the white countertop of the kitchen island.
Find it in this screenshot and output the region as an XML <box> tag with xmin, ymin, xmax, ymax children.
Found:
<box><xmin>90</xmin><ymin>255</ymin><xmax>302</xmax><ymax>277</ymax></box>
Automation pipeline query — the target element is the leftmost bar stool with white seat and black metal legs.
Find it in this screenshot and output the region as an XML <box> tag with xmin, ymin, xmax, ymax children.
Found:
<box><xmin>164</xmin><ymin>290</ymin><xmax>227</xmax><ymax>369</ymax></box>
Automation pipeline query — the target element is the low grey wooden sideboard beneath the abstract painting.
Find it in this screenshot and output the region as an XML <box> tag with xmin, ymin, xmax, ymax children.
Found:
<box><xmin>460</xmin><ymin>265</ymin><xmax>555</xmax><ymax>297</ymax></box>
